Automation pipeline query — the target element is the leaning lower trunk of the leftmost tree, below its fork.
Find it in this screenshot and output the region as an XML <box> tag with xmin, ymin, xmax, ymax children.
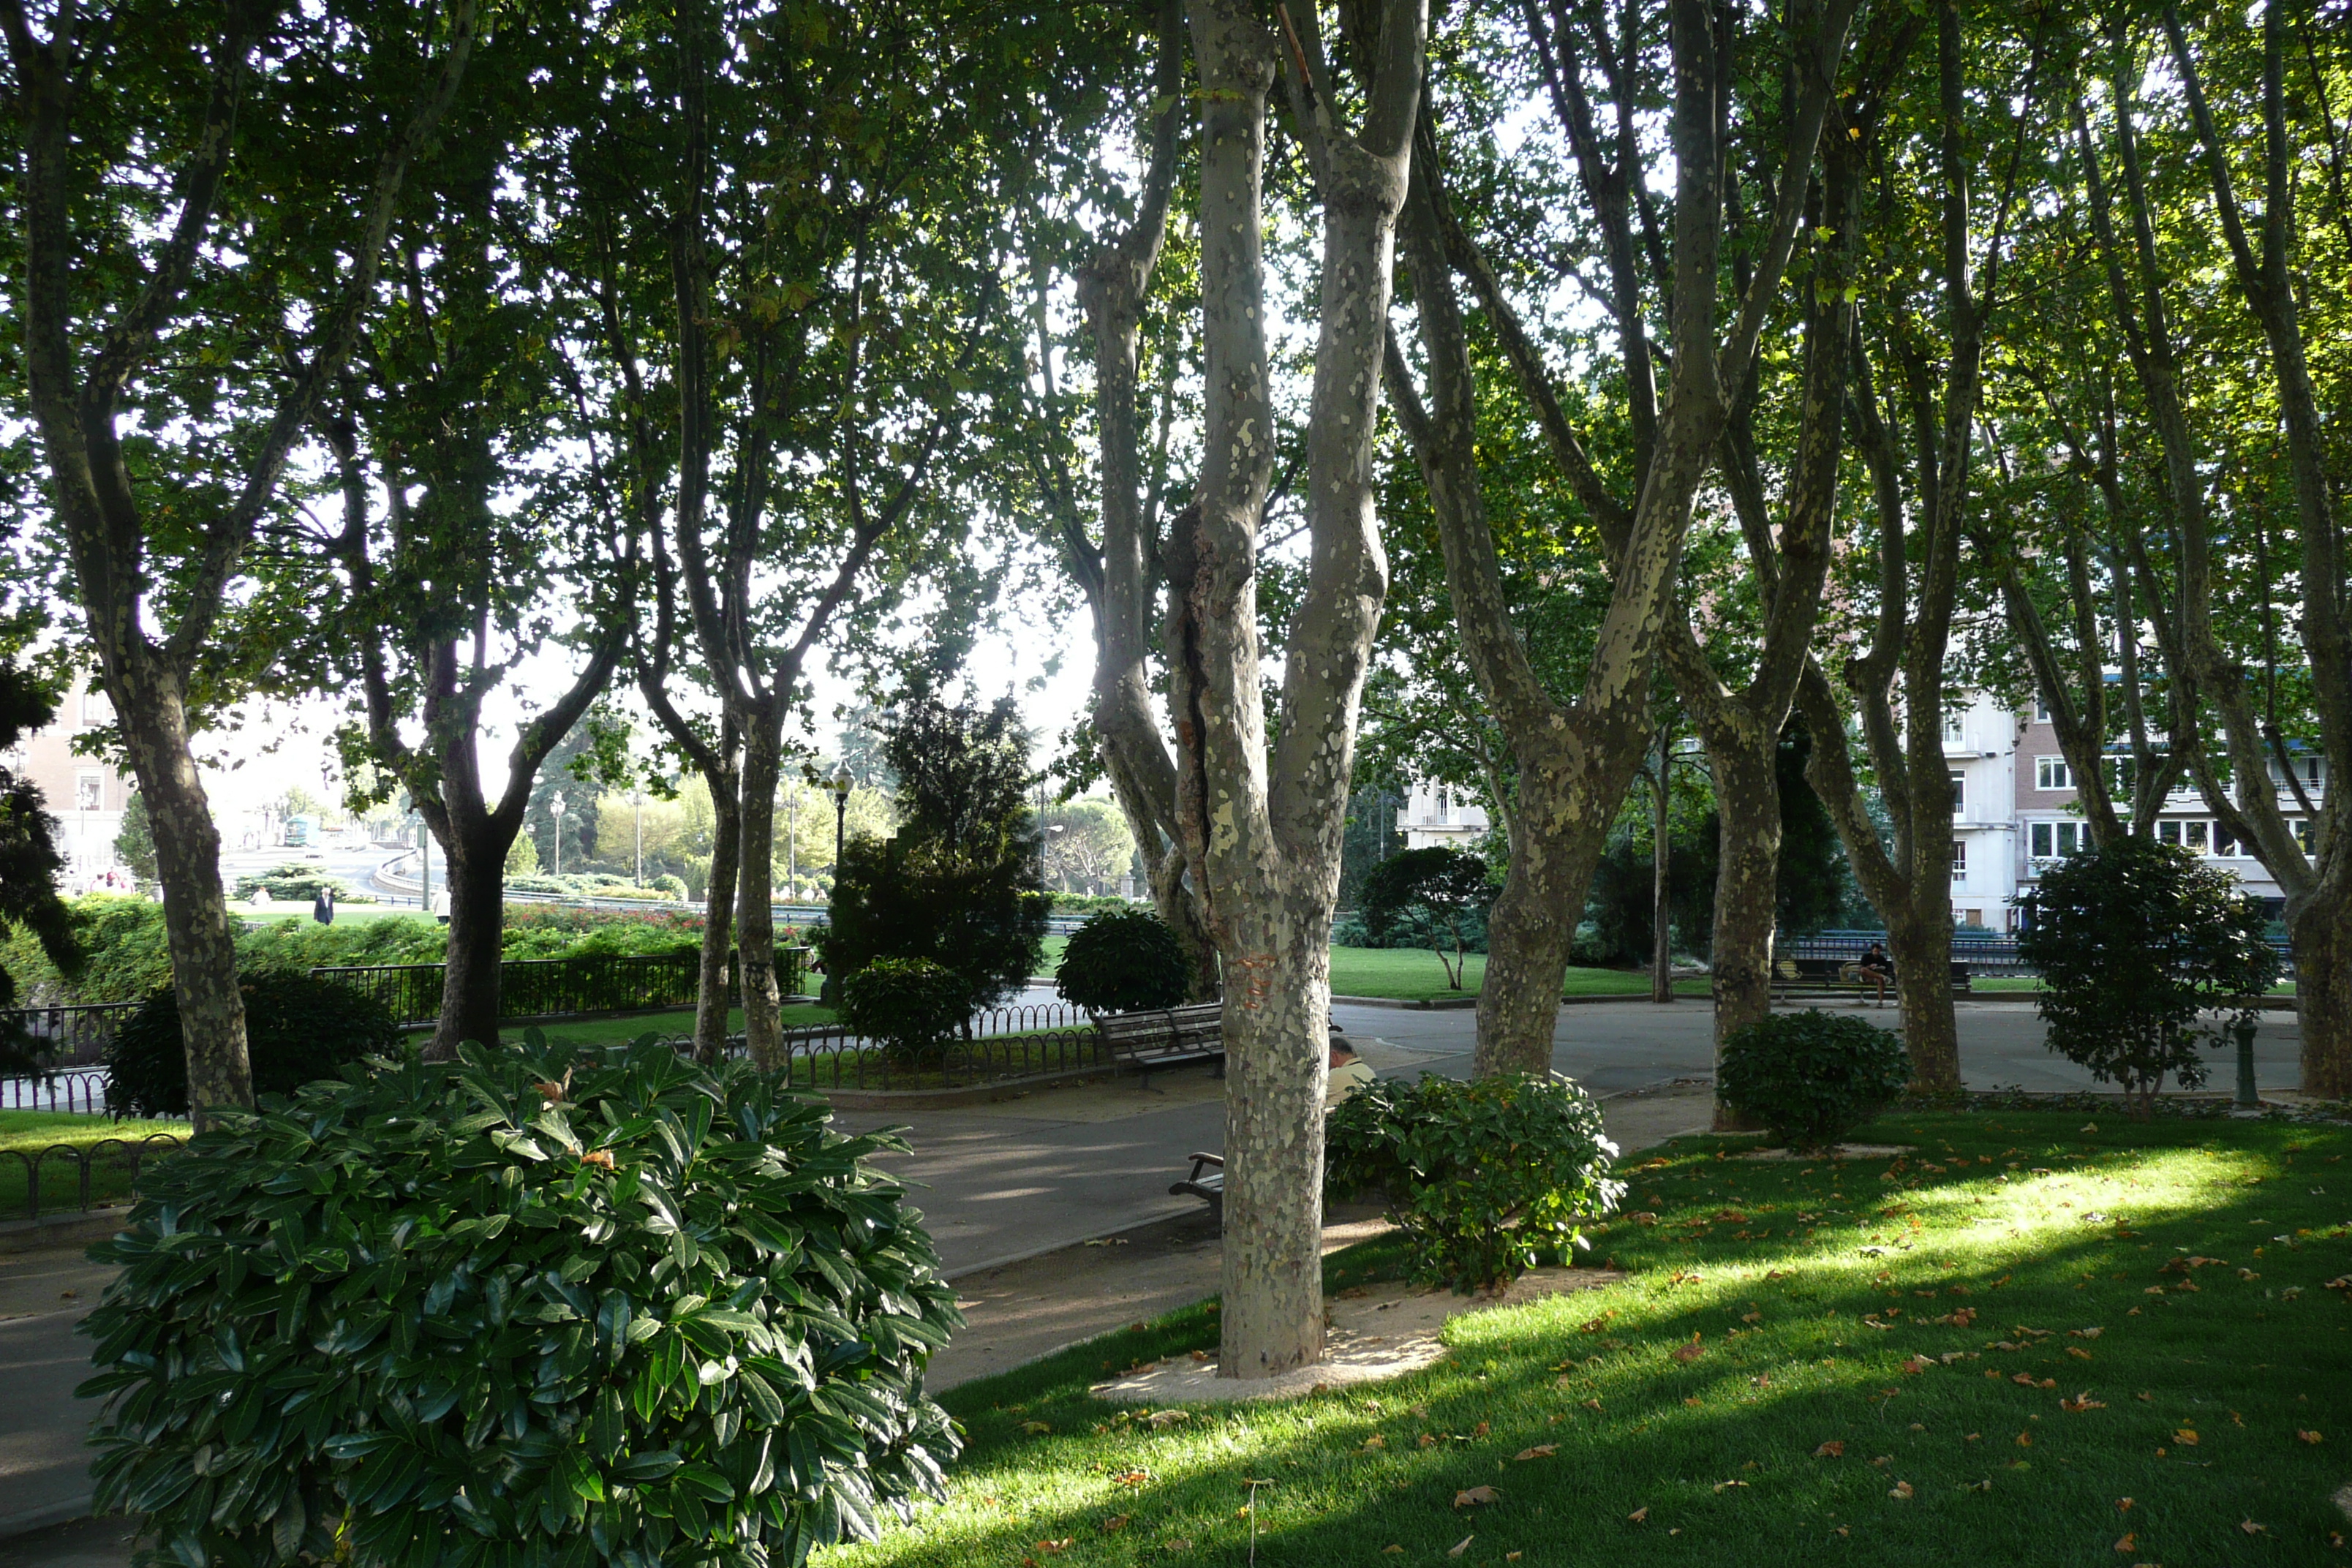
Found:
<box><xmin>108</xmin><ymin>682</ymin><xmax>254</xmax><ymax>1131</ymax></box>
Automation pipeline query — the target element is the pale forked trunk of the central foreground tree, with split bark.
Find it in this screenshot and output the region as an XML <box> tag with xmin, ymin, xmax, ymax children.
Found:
<box><xmin>1166</xmin><ymin>0</ymin><xmax>1428</xmax><ymax>1378</ymax></box>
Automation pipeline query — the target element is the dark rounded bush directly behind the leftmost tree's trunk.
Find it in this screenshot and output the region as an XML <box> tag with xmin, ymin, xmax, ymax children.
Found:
<box><xmin>106</xmin><ymin>971</ymin><xmax>400</xmax><ymax>1117</ymax></box>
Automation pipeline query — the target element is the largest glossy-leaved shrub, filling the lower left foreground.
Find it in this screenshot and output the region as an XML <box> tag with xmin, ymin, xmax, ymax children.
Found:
<box><xmin>83</xmin><ymin>1032</ymin><xmax>960</xmax><ymax>1568</ymax></box>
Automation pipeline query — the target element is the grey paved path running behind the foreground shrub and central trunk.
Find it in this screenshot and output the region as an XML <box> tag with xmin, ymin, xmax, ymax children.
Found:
<box><xmin>0</xmin><ymin>990</ymin><xmax>2298</xmax><ymax>1568</ymax></box>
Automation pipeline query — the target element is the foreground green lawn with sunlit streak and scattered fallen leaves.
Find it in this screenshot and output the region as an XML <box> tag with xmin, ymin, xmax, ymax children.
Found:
<box><xmin>846</xmin><ymin>1109</ymin><xmax>2352</xmax><ymax>1568</ymax></box>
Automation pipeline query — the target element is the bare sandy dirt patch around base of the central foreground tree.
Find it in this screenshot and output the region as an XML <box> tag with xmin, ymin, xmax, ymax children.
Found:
<box><xmin>1093</xmin><ymin>1270</ymin><xmax>1625</xmax><ymax>1408</ymax></box>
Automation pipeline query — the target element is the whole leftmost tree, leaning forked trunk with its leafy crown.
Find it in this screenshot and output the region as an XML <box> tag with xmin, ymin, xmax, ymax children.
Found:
<box><xmin>0</xmin><ymin>0</ymin><xmax>478</xmax><ymax>1123</ymax></box>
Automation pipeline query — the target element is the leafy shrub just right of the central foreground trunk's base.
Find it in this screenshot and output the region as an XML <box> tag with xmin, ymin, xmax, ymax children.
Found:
<box><xmin>1324</xmin><ymin>1074</ymin><xmax>1625</xmax><ymax>1291</ymax></box>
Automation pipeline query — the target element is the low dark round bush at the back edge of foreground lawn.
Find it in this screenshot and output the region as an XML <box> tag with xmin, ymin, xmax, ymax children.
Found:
<box><xmin>1717</xmin><ymin>1009</ymin><xmax>1910</xmax><ymax>1150</ymax></box>
